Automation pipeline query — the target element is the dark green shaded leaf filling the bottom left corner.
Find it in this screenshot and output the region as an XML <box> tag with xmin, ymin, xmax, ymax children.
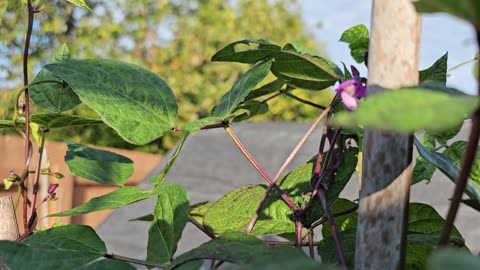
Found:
<box><xmin>0</xmin><ymin>224</ymin><xmax>107</xmax><ymax>270</ymax></box>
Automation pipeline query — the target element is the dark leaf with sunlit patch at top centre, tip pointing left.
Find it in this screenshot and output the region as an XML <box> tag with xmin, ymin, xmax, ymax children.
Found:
<box><xmin>212</xmin><ymin>39</ymin><xmax>280</xmax><ymax>64</ymax></box>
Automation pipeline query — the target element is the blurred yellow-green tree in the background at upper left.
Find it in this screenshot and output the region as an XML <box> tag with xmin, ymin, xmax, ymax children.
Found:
<box><xmin>0</xmin><ymin>0</ymin><xmax>332</xmax><ymax>152</ymax></box>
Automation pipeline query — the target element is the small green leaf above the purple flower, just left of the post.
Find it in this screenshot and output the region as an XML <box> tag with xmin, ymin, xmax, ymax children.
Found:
<box><xmin>339</xmin><ymin>24</ymin><xmax>370</xmax><ymax>63</ymax></box>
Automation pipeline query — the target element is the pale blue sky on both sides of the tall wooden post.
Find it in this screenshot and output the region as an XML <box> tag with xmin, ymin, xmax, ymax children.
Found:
<box><xmin>300</xmin><ymin>0</ymin><xmax>478</xmax><ymax>94</ymax></box>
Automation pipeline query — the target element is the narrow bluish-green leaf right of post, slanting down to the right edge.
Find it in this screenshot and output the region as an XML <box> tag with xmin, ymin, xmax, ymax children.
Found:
<box><xmin>414</xmin><ymin>138</ymin><xmax>480</xmax><ymax>201</ymax></box>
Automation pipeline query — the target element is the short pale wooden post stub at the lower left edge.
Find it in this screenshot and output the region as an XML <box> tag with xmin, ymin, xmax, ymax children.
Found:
<box><xmin>0</xmin><ymin>196</ymin><xmax>19</xmax><ymax>270</ymax></box>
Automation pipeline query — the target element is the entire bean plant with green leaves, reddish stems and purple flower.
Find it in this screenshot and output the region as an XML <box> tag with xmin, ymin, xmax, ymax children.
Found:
<box><xmin>0</xmin><ymin>0</ymin><xmax>480</xmax><ymax>270</ymax></box>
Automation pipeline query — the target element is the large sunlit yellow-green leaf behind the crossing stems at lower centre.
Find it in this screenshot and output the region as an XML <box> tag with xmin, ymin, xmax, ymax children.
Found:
<box><xmin>203</xmin><ymin>148</ymin><xmax>358</xmax><ymax>235</ymax></box>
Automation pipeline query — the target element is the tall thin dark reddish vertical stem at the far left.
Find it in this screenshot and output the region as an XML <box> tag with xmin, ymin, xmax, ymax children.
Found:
<box><xmin>21</xmin><ymin>0</ymin><xmax>34</xmax><ymax>231</ymax></box>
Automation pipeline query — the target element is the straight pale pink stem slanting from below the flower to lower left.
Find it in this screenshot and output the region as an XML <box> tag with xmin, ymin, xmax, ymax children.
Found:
<box><xmin>246</xmin><ymin>107</ymin><xmax>330</xmax><ymax>233</ymax></box>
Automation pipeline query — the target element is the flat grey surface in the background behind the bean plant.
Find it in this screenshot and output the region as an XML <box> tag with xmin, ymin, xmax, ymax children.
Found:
<box><xmin>97</xmin><ymin>122</ymin><xmax>480</xmax><ymax>259</ymax></box>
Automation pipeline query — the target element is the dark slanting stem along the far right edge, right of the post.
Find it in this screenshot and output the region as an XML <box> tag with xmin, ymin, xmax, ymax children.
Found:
<box><xmin>438</xmin><ymin>29</ymin><xmax>480</xmax><ymax>247</ymax></box>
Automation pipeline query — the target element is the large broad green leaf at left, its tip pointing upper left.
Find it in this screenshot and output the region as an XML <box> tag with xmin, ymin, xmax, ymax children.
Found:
<box><xmin>45</xmin><ymin>60</ymin><xmax>177</xmax><ymax>145</ymax></box>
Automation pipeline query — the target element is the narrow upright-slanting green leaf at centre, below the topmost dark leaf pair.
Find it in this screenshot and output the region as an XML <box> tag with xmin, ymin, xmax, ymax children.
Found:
<box><xmin>213</xmin><ymin>60</ymin><xmax>272</xmax><ymax>118</ymax></box>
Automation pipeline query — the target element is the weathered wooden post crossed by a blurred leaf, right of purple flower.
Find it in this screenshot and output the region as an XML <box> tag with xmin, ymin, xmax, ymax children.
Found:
<box><xmin>355</xmin><ymin>0</ymin><xmax>420</xmax><ymax>270</ymax></box>
